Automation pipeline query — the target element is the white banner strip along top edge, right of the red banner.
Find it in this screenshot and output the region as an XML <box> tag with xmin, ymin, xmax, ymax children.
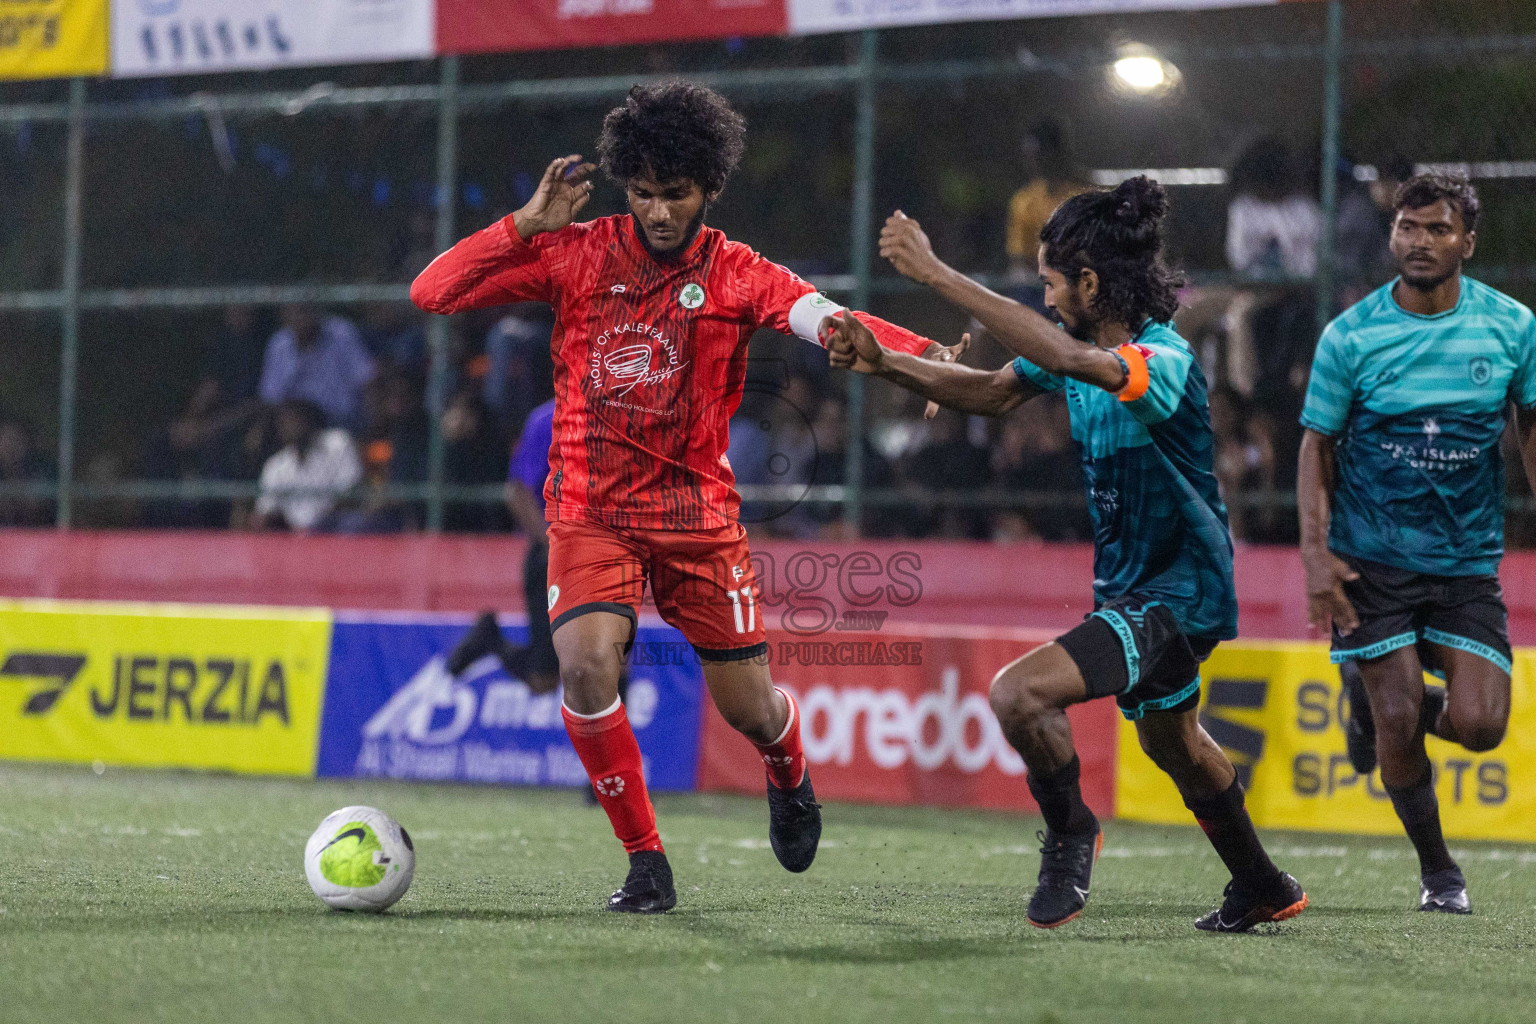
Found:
<box><xmin>786</xmin><ymin>0</ymin><xmax>1286</xmax><ymax>35</ymax></box>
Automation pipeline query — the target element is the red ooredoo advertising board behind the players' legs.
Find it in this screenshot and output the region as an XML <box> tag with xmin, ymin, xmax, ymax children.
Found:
<box><xmin>699</xmin><ymin>626</ymin><xmax>1117</xmax><ymax>817</ymax></box>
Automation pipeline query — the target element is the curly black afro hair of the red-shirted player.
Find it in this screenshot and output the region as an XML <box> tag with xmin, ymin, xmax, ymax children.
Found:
<box><xmin>598</xmin><ymin>81</ymin><xmax>746</xmax><ymax>197</ymax></box>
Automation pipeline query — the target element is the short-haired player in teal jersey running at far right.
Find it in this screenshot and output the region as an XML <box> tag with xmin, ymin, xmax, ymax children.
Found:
<box><xmin>1296</xmin><ymin>175</ymin><xmax>1536</xmax><ymax>913</ymax></box>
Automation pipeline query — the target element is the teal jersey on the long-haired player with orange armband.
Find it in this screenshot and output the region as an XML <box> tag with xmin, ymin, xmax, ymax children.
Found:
<box><xmin>1014</xmin><ymin>321</ymin><xmax>1238</xmax><ymax>640</ymax></box>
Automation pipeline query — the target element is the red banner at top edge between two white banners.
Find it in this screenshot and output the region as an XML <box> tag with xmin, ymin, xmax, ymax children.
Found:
<box><xmin>438</xmin><ymin>0</ymin><xmax>786</xmax><ymax>54</ymax></box>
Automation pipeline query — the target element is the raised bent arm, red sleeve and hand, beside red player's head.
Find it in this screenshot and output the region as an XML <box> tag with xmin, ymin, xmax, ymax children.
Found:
<box><xmin>410</xmin><ymin>154</ymin><xmax>594</xmax><ymax>315</ymax></box>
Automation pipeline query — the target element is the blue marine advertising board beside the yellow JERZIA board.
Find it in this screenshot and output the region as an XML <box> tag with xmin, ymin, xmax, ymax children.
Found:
<box><xmin>318</xmin><ymin>614</ymin><xmax>703</xmax><ymax>791</ymax></box>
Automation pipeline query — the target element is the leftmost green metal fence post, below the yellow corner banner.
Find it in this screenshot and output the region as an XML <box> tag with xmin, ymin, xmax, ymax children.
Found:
<box><xmin>55</xmin><ymin>78</ymin><xmax>86</xmax><ymax>530</ymax></box>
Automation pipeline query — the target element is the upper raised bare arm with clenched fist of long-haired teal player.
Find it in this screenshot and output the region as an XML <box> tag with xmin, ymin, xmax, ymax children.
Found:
<box><xmin>880</xmin><ymin>210</ymin><xmax>1126</xmax><ymax>391</ymax></box>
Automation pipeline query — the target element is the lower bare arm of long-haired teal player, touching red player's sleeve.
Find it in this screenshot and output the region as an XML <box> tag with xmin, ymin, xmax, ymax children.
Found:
<box><xmin>826</xmin><ymin>315</ymin><xmax>1038</xmax><ymax>416</ymax></box>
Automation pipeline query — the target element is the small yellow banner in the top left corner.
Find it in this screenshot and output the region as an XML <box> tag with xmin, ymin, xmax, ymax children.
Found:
<box><xmin>0</xmin><ymin>0</ymin><xmax>111</xmax><ymax>80</ymax></box>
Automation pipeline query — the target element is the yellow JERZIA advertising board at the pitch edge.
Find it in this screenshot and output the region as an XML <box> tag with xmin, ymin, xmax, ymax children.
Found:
<box><xmin>0</xmin><ymin>601</ymin><xmax>330</xmax><ymax>775</ymax></box>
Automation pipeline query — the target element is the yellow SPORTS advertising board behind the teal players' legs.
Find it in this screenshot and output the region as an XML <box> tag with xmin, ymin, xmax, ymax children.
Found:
<box><xmin>1115</xmin><ymin>640</ymin><xmax>1536</xmax><ymax>841</ymax></box>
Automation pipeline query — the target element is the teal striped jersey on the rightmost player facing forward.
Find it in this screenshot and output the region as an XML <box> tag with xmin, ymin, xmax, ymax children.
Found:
<box><xmin>1301</xmin><ymin>278</ymin><xmax>1536</xmax><ymax>576</ymax></box>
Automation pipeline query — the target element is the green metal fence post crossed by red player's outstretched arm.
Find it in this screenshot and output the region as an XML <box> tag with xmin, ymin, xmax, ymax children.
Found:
<box><xmin>843</xmin><ymin>29</ymin><xmax>880</xmax><ymax>536</ymax></box>
